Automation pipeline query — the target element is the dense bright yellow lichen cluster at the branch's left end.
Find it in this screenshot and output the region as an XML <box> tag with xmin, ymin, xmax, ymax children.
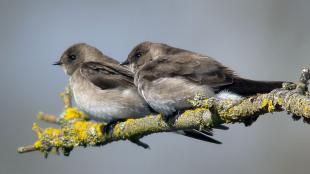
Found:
<box><xmin>32</xmin><ymin>114</ymin><xmax>103</xmax><ymax>154</ymax></box>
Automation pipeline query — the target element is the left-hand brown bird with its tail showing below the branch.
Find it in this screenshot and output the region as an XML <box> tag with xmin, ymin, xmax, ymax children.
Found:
<box><xmin>54</xmin><ymin>43</ymin><xmax>221</xmax><ymax>148</ymax></box>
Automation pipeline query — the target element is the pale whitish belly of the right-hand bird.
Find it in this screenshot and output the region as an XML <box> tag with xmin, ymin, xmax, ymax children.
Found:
<box><xmin>138</xmin><ymin>77</ymin><xmax>215</xmax><ymax>115</ymax></box>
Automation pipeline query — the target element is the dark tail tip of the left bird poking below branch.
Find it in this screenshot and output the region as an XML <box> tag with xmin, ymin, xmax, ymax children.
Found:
<box><xmin>177</xmin><ymin>129</ymin><xmax>222</xmax><ymax>144</ymax></box>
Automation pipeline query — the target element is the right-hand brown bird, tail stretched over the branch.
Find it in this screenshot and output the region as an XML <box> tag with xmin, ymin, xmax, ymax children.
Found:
<box><xmin>123</xmin><ymin>42</ymin><xmax>283</xmax><ymax>116</ymax></box>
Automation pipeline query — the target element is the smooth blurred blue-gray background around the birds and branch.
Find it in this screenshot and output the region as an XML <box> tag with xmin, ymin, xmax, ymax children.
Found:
<box><xmin>0</xmin><ymin>0</ymin><xmax>310</xmax><ymax>174</ymax></box>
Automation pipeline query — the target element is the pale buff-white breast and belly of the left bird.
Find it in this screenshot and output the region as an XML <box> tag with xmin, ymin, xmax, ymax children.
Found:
<box><xmin>70</xmin><ymin>76</ymin><xmax>150</xmax><ymax>122</ymax></box>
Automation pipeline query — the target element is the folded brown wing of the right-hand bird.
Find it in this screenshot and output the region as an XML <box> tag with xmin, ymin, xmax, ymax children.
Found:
<box><xmin>138</xmin><ymin>54</ymin><xmax>234</xmax><ymax>88</ymax></box>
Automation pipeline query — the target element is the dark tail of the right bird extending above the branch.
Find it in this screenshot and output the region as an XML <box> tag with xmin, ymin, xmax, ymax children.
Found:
<box><xmin>220</xmin><ymin>77</ymin><xmax>285</xmax><ymax>96</ymax></box>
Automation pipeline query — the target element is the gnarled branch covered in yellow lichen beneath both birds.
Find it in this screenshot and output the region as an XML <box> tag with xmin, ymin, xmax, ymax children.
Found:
<box><xmin>18</xmin><ymin>68</ymin><xmax>310</xmax><ymax>155</ymax></box>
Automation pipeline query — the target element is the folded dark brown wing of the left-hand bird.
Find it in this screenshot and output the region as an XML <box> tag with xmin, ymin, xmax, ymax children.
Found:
<box><xmin>80</xmin><ymin>62</ymin><xmax>134</xmax><ymax>89</ymax></box>
